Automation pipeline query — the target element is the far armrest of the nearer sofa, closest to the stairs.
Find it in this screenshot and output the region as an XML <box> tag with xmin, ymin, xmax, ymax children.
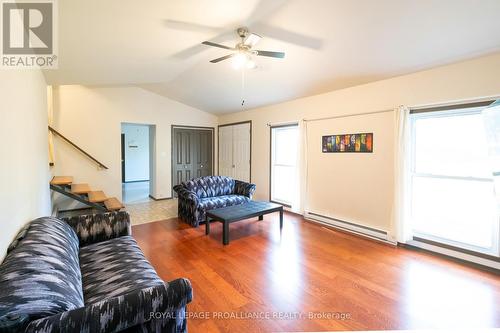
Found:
<box><xmin>63</xmin><ymin>211</ymin><xmax>131</xmax><ymax>246</ymax></box>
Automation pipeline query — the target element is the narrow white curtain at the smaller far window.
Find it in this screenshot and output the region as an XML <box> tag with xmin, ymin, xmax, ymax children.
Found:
<box><xmin>292</xmin><ymin>120</ymin><xmax>307</xmax><ymax>214</ymax></box>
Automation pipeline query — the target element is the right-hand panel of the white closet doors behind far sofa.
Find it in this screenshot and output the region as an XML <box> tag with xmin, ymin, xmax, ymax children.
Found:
<box><xmin>231</xmin><ymin>123</ymin><xmax>250</xmax><ymax>182</ymax></box>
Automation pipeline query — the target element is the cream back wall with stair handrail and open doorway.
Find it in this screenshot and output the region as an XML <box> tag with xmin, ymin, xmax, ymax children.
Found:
<box><xmin>53</xmin><ymin>85</ymin><xmax>217</xmax><ymax>199</ymax></box>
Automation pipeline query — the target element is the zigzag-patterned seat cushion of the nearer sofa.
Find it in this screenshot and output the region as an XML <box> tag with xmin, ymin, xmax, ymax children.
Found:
<box><xmin>80</xmin><ymin>236</ymin><xmax>164</xmax><ymax>304</ymax></box>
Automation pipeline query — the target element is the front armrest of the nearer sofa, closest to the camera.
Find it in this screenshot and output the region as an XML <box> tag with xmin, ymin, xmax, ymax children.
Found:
<box><xmin>26</xmin><ymin>279</ymin><xmax>192</xmax><ymax>333</ymax></box>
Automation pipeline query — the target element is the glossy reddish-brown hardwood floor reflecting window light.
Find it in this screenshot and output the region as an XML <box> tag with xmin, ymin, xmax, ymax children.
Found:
<box><xmin>133</xmin><ymin>214</ymin><xmax>500</xmax><ymax>332</ymax></box>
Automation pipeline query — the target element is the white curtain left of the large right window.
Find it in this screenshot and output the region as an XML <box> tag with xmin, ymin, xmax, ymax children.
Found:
<box><xmin>389</xmin><ymin>106</ymin><xmax>412</xmax><ymax>243</ymax></box>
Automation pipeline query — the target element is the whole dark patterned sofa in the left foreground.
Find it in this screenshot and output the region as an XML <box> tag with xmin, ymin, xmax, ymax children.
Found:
<box><xmin>0</xmin><ymin>212</ymin><xmax>192</xmax><ymax>333</ymax></box>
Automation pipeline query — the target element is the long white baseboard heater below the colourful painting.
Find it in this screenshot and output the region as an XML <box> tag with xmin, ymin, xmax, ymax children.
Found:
<box><xmin>305</xmin><ymin>212</ymin><xmax>396</xmax><ymax>245</ymax></box>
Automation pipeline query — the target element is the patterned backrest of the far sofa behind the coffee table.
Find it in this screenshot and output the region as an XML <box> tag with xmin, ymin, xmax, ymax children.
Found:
<box><xmin>184</xmin><ymin>176</ymin><xmax>234</xmax><ymax>198</ymax></box>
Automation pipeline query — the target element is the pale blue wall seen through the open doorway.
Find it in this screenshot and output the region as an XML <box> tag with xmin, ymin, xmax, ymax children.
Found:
<box><xmin>122</xmin><ymin>124</ymin><xmax>149</xmax><ymax>182</ymax></box>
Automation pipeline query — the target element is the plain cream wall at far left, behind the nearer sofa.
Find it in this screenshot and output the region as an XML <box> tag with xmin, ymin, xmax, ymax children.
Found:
<box><xmin>0</xmin><ymin>70</ymin><xmax>51</xmax><ymax>262</ymax></box>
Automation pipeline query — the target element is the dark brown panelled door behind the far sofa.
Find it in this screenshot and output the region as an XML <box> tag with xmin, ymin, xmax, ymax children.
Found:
<box><xmin>172</xmin><ymin>128</ymin><xmax>213</xmax><ymax>187</ymax></box>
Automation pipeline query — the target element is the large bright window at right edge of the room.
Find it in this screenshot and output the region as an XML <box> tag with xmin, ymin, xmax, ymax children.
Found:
<box><xmin>410</xmin><ymin>108</ymin><xmax>499</xmax><ymax>256</ymax></box>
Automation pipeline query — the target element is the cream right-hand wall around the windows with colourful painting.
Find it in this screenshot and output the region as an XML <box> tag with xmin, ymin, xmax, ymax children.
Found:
<box><xmin>219</xmin><ymin>53</ymin><xmax>500</xmax><ymax>231</ymax></box>
